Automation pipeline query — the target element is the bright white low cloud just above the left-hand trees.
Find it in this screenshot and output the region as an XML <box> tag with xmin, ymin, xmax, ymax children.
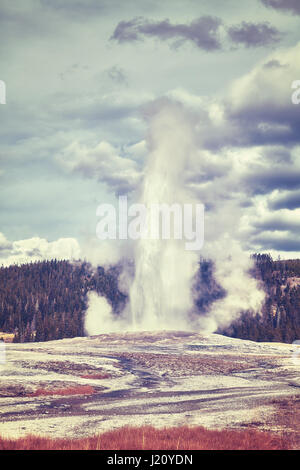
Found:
<box><xmin>0</xmin><ymin>233</ymin><xmax>81</xmax><ymax>266</ymax></box>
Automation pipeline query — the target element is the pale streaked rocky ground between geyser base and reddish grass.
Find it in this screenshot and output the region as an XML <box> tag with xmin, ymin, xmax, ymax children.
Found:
<box><xmin>0</xmin><ymin>332</ymin><xmax>300</xmax><ymax>446</ymax></box>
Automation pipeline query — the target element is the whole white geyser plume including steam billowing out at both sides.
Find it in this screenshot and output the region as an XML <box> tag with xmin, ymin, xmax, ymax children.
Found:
<box><xmin>85</xmin><ymin>101</ymin><xmax>264</xmax><ymax>334</ymax></box>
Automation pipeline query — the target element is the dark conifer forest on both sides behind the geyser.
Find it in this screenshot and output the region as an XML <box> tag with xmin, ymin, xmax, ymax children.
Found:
<box><xmin>0</xmin><ymin>254</ymin><xmax>300</xmax><ymax>343</ymax></box>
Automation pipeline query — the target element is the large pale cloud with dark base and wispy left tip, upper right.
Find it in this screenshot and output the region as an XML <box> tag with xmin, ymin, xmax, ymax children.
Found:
<box><xmin>168</xmin><ymin>43</ymin><xmax>300</xmax><ymax>151</ymax></box>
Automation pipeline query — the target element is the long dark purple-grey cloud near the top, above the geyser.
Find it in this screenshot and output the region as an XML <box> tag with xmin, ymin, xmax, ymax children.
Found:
<box><xmin>111</xmin><ymin>16</ymin><xmax>222</xmax><ymax>51</ymax></box>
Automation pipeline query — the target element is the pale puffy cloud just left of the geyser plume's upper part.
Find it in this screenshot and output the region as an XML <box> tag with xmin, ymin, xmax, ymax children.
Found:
<box><xmin>57</xmin><ymin>141</ymin><xmax>141</xmax><ymax>194</ymax></box>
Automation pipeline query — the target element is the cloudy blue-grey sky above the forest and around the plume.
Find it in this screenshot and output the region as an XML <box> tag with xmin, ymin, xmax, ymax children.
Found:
<box><xmin>0</xmin><ymin>0</ymin><xmax>300</xmax><ymax>265</ymax></box>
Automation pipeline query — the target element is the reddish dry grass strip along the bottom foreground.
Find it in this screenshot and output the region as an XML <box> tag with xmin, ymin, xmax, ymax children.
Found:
<box><xmin>0</xmin><ymin>426</ymin><xmax>290</xmax><ymax>450</ymax></box>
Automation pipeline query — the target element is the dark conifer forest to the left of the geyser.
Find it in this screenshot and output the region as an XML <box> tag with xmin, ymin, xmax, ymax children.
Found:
<box><xmin>0</xmin><ymin>260</ymin><xmax>126</xmax><ymax>342</ymax></box>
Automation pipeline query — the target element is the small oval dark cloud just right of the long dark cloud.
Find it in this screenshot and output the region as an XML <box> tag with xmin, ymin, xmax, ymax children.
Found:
<box><xmin>227</xmin><ymin>21</ymin><xmax>281</xmax><ymax>47</ymax></box>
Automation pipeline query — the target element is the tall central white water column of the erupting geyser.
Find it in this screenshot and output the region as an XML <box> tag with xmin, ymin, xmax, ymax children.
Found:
<box><xmin>130</xmin><ymin>104</ymin><xmax>199</xmax><ymax>329</ymax></box>
